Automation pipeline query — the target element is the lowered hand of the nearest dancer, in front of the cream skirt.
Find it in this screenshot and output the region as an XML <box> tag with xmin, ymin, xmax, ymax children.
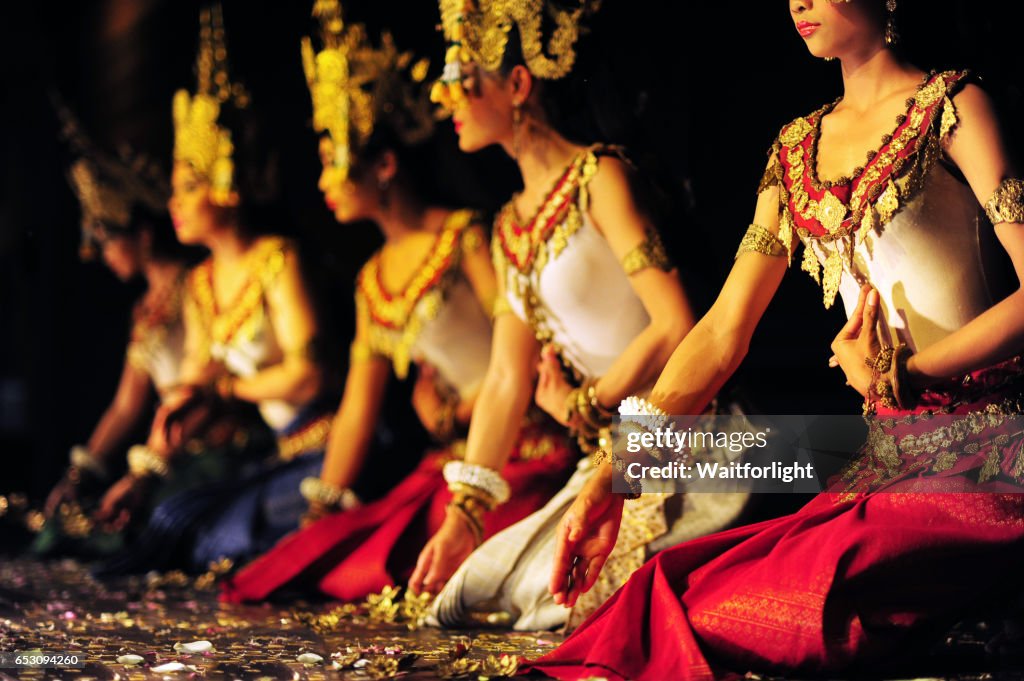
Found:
<box><xmin>548</xmin><ymin>464</ymin><xmax>625</xmax><ymax>607</ymax></box>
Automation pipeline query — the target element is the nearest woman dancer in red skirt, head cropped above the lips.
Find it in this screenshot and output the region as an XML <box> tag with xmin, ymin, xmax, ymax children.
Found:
<box><xmin>537</xmin><ymin>0</ymin><xmax>1024</xmax><ymax>679</ymax></box>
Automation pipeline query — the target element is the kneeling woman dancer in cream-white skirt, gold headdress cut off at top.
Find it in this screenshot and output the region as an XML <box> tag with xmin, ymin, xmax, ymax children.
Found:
<box><xmin>411</xmin><ymin>1</ymin><xmax>746</xmax><ymax>629</ymax></box>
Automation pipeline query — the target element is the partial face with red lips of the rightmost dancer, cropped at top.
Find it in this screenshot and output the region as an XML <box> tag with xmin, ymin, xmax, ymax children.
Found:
<box><xmin>790</xmin><ymin>0</ymin><xmax>885</xmax><ymax>58</ymax></box>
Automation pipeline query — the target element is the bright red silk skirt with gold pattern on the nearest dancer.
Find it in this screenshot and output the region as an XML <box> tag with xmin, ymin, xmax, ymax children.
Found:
<box><xmin>530</xmin><ymin>360</ymin><xmax>1024</xmax><ymax>681</ymax></box>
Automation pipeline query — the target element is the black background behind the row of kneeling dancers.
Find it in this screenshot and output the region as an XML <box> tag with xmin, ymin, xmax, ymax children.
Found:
<box><xmin>0</xmin><ymin>0</ymin><xmax>1021</xmax><ymax>497</ymax></box>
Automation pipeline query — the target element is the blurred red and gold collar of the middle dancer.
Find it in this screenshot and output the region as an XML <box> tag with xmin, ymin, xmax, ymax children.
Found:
<box><xmin>356</xmin><ymin>210</ymin><xmax>468</xmax><ymax>329</ymax></box>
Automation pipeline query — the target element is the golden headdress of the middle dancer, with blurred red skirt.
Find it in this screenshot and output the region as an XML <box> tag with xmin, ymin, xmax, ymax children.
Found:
<box><xmin>302</xmin><ymin>0</ymin><xmax>434</xmax><ymax>178</ymax></box>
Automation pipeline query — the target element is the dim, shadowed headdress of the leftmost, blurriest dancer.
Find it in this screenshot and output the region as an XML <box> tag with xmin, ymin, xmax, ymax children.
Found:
<box><xmin>53</xmin><ymin>94</ymin><xmax>169</xmax><ymax>260</ymax></box>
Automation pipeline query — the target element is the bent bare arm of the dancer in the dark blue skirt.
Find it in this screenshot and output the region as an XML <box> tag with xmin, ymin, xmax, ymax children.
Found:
<box><xmin>232</xmin><ymin>245</ymin><xmax>324</xmax><ymax>403</ymax></box>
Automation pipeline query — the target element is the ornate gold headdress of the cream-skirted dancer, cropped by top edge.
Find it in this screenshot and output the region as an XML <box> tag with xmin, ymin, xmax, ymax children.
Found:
<box><xmin>430</xmin><ymin>0</ymin><xmax>600</xmax><ymax>110</ymax></box>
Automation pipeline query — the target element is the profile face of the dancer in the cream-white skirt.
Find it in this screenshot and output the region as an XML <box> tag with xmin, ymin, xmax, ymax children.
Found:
<box><xmin>452</xmin><ymin>65</ymin><xmax>514</xmax><ymax>152</ymax></box>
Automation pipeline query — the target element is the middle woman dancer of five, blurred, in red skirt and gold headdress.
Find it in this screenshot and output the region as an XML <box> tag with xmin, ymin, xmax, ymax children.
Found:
<box><xmin>225</xmin><ymin>2</ymin><xmax>572</xmax><ymax>600</ymax></box>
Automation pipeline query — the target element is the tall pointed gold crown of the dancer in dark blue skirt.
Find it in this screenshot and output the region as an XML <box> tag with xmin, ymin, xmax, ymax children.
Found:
<box><xmin>173</xmin><ymin>4</ymin><xmax>249</xmax><ymax>205</ymax></box>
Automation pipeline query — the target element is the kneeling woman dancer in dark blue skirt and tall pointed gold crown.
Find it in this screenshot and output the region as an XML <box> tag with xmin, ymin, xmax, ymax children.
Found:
<box><xmin>98</xmin><ymin>7</ymin><xmax>331</xmax><ymax>571</ymax></box>
